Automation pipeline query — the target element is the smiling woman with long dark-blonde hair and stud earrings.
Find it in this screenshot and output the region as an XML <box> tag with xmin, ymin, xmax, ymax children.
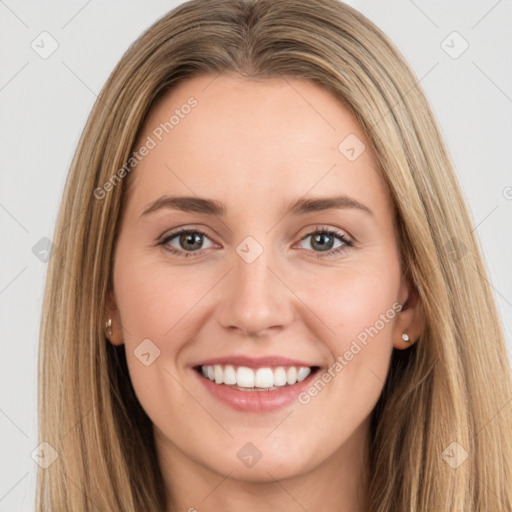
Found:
<box><xmin>38</xmin><ymin>0</ymin><xmax>512</xmax><ymax>512</ymax></box>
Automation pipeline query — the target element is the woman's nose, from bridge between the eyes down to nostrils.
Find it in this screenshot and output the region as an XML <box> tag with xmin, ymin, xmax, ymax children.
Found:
<box><xmin>220</xmin><ymin>236</ymin><xmax>290</xmax><ymax>335</ymax></box>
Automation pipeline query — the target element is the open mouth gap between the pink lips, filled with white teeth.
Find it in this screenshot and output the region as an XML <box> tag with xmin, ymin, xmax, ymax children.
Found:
<box><xmin>194</xmin><ymin>364</ymin><xmax>320</xmax><ymax>392</ymax></box>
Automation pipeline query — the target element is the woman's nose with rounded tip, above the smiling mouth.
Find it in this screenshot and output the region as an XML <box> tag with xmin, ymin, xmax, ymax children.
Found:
<box><xmin>218</xmin><ymin>241</ymin><xmax>293</xmax><ymax>337</ymax></box>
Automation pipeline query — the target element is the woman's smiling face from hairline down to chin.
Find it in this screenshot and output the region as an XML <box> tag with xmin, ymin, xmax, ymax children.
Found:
<box><xmin>108</xmin><ymin>75</ymin><xmax>417</xmax><ymax>481</ymax></box>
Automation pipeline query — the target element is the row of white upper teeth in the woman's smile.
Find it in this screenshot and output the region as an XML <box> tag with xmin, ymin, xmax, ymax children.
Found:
<box><xmin>201</xmin><ymin>364</ymin><xmax>311</xmax><ymax>388</ymax></box>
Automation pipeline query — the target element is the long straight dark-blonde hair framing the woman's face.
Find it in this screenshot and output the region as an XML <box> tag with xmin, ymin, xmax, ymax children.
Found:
<box><xmin>37</xmin><ymin>0</ymin><xmax>512</xmax><ymax>512</ymax></box>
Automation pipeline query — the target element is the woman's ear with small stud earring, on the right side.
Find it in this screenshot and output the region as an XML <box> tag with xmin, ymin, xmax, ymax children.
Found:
<box><xmin>393</xmin><ymin>276</ymin><xmax>425</xmax><ymax>350</ymax></box>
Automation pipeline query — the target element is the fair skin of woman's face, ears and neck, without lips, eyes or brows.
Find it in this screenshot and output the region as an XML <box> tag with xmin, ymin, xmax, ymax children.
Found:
<box><xmin>106</xmin><ymin>75</ymin><xmax>422</xmax><ymax>512</ymax></box>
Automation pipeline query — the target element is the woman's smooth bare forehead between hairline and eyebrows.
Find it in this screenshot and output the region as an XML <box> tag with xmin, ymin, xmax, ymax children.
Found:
<box><xmin>126</xmin><ymin>75</ymin><xmax>386</xmax><ymax>214</ymax></box>
